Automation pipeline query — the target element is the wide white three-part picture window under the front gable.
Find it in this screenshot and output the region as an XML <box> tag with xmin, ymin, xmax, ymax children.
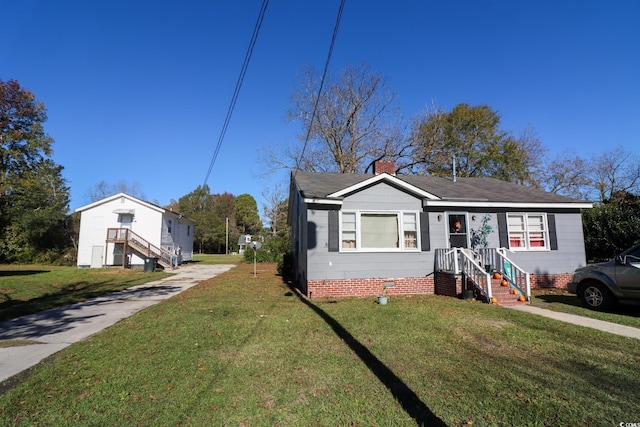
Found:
<box><xmin>340</xmin><ymin>212</ymin><xmax>419</xmax><ymax>252</ymax></box>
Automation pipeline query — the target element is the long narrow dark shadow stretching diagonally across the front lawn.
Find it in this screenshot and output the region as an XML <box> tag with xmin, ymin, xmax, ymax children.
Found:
<box><xmin>290</xmin><ymin>285</ymin><xmax>446</xmax><ymax>426</ymax></box>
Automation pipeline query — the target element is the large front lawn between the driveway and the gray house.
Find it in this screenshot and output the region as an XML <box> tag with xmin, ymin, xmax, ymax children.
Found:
<box><xmin>0</xmin><ymin>264</ymin><xmax>640</xmax><ymax>426</ymax></box>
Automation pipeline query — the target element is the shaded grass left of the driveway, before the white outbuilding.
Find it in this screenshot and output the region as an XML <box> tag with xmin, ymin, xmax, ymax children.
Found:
<box><xmin>0</xmin><ymin>265</ymin><xmax>170</xmax><ymax>321</ymax></box>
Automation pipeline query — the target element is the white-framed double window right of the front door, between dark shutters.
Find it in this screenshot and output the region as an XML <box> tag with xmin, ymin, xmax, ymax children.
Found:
<box><xmin>507</xmin><ymin>213</ymin><xmax>549</xmax><ymax>250</ymax></box>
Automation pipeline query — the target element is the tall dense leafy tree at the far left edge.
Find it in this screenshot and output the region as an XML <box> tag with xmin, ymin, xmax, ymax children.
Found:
<box><xmin>0</xmin><ymin>80</ymin><xmax>69</xmax><ymax>262</ymax></box>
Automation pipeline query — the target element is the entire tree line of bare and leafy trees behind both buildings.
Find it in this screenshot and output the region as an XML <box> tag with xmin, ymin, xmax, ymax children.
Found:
<box><xmin>0</xmin><ymin>70</ymin><xmax>640</xmax><ymax>263</ymax></box>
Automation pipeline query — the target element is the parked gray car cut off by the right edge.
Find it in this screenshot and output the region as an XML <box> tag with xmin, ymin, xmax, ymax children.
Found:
<box><xmin>567</xmin><ymin>244</ymin><xmax>640</xmax><ymax>310</ymax></box>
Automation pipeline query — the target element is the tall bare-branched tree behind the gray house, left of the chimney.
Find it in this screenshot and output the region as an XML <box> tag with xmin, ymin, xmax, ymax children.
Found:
<box><xmin>264</xmin><ymin>64</ymin><xmax>401</xmax><ymax>173</ymax></box>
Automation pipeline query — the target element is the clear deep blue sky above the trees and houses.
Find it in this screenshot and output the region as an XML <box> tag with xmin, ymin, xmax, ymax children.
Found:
<box><xmin>0</xmin><ymin>0</ymin><xmax>640</xmax><ymax>214</ymax></box>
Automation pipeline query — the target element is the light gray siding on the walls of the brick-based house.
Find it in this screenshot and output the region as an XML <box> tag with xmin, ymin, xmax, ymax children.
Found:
<box><xmin>290</xmin><ymin>177</ymin><xmax>585</xmax><ymax>283</ymax></box>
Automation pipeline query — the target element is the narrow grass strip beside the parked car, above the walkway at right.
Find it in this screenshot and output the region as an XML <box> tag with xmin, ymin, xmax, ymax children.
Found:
<box><xmin>531</xmin><ymin>289</ymin><xmax>640</xmax><ymax>328</ymax></box>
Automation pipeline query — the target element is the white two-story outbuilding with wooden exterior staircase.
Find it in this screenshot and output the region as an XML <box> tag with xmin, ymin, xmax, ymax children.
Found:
<box><xmin>76</xmin><ymin>193</ymin><xmax>195</xmax><ymax>268</ymax></box>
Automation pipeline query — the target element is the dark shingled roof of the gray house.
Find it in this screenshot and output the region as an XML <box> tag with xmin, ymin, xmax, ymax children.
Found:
<box><xmin>292</xmin><ymin>171</ymin><xmax>587</xmax><ymax>204</ymax></box>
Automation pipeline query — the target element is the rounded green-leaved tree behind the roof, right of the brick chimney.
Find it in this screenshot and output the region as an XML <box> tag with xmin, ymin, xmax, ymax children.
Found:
<box><xmin>410</xmin><ymin>104</ymin><xmax>544</xmax><ymax>185</ymax></box>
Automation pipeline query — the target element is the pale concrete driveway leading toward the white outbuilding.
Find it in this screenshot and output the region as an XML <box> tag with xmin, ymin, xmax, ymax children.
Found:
<box><xmin>0</xmin><ymin>264</ymin><xmax>234</xmax><ymax>382</ymax></box>
